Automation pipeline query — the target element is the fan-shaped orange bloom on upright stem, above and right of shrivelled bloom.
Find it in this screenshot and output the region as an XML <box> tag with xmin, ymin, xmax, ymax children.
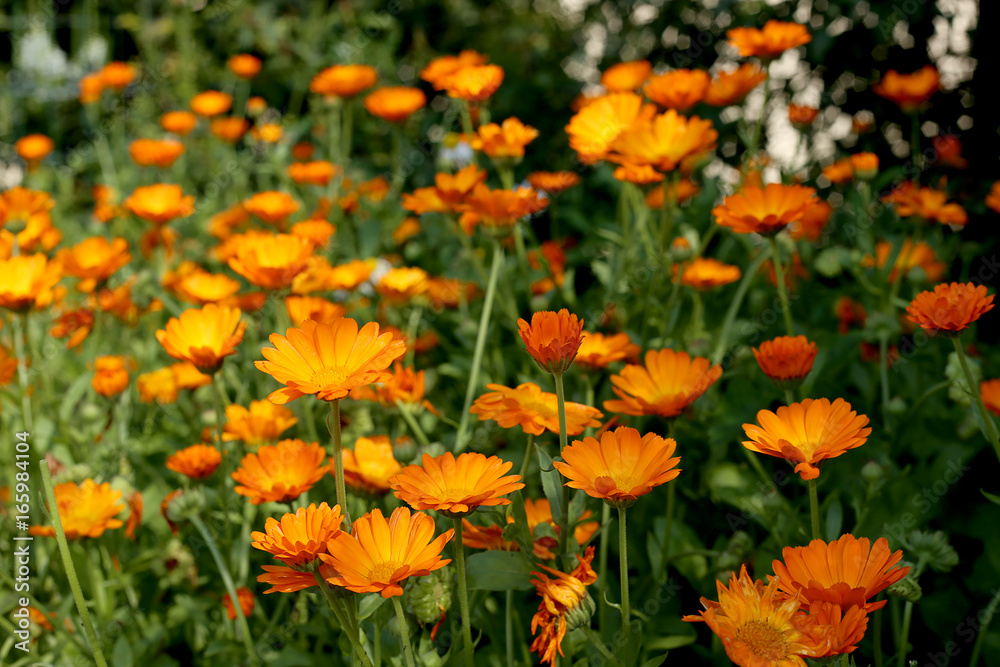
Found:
<box><xmin>552</xmin><ymin>426</ymin><xmax>681</xmax><ymax>508</ymax></box>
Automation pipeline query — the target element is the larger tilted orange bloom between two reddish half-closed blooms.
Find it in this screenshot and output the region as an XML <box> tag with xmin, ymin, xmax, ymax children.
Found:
<box><xmin>604</xmin><ymin>349</ymin><xmax>722</xmax><ymax>417</ymax></box>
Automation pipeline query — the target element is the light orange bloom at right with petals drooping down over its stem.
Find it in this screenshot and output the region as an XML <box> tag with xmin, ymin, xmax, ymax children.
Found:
<box><xmin>743</xmin><ymin>398</ymin><xmax>872</xmax><ymax>480</ymax></box>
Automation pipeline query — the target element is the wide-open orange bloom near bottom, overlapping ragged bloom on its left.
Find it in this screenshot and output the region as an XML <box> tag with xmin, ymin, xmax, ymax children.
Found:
<box><xmin>320</xmin><ymin>507</ymin><xmax>455</xmax><ymax>598</ymax></box>
